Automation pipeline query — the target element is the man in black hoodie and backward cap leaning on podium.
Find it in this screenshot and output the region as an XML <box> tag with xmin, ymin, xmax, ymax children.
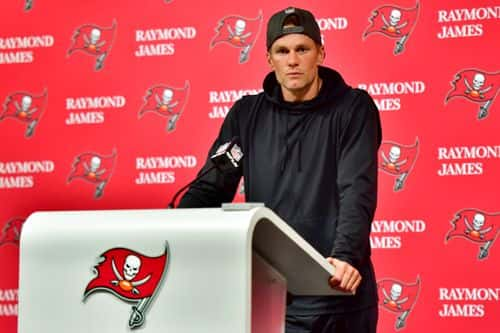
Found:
<box><xmin>179</xmin><ymin>7</ymin><xmax>381</xmax><ymax>333</ymax></box>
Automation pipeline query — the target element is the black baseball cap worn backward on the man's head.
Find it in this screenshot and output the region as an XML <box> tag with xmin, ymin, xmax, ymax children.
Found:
<box><xmin>266</xmin><ymin>7</ymin><xmax>322</xmax><ymax>50</ymax></box>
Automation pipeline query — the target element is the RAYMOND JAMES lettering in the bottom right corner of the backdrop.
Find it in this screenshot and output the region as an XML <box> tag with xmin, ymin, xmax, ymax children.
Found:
<box><xmin>438</xmin><ymin>287</ymin><xmax>500</xmax><ymax>318</ymax></box>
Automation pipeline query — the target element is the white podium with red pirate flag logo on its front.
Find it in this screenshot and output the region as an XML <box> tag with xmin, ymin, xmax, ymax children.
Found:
<box><xmin>18</xmin><ymin>205</ymin><xmax>348</xmax><ymax>333</ymax></box>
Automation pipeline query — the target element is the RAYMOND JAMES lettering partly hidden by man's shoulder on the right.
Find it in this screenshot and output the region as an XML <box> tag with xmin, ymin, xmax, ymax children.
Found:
<box><xmin>358</xmin><ymin>81</ymin><xmax>425</xmax><ymax>111</ymax></box>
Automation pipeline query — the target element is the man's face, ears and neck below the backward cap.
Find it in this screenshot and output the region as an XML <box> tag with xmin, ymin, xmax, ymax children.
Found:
<box><xmin>267</xmin><ymin>34</ymin><xmax>325</xmax><ymax>102</ymax></box>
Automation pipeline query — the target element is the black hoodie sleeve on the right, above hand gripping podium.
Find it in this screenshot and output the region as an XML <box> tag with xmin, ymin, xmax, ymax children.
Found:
<box><xmin>332</xmin><ymin>90</ymin><xmax>382</xmax><ymax>269</ymax></box>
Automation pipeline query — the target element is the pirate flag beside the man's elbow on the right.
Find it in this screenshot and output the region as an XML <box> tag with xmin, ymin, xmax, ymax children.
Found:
<box><xmin>379</xmin><ymin>138</ymin><xmax>418</xmax><ymax>192</ymax></box>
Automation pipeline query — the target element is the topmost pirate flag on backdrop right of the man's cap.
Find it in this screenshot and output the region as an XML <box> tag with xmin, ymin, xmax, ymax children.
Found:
<box><xmin>363</xmin><ymin>2</ymin><xmax>420</xmax><ymax>55</ymax></box>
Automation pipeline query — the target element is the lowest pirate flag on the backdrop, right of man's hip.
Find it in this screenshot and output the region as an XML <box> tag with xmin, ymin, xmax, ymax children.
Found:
<box><xmin>377</xmin><ymin>277</ymin><xmax>420</xmax><ymax>330</ymax></box>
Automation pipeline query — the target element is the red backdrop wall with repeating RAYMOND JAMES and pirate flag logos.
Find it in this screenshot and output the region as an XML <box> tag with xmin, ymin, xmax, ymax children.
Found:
<box><xmin>0</xmin><ymin>0</ymin><xmax>500</xmax><ymax>333</ymax></box>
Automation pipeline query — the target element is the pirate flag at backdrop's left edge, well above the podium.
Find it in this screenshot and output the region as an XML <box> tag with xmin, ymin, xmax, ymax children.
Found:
<box><xmin>0</xmin><ymin>89</ymin><xmax>47</xmax><ymax>138</ymax></box>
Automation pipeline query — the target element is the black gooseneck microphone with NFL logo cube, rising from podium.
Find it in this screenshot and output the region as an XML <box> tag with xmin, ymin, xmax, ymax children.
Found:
<box><xmin>167</xmin><ymin>136</ymin><xmax>244</xmax><ymax>208</ymax></box>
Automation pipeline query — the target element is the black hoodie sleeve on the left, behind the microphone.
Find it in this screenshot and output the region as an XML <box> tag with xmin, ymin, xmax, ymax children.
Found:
<box><xmin>178</xmin><ymin>101</ymin><xmax>242</xmax><ymax>208</ymax></box>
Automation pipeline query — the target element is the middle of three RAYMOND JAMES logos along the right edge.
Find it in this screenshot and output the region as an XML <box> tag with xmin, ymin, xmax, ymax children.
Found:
<box><xmin>437</xmin><ymin>145</ymin><xmax>500</xmax><ymax>177</ymax></box>
